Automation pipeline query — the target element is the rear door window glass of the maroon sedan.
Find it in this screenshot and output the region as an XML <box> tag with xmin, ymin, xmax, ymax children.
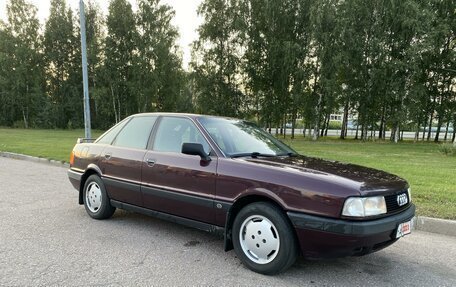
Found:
<box><xmin>113</xmin><ymin>116</ymin><xmax>157</xmax><ymax>149</ymax></box>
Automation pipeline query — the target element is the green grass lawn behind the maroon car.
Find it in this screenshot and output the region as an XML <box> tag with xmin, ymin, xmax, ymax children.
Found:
<box><xmin>0</xmin><ymin>128</ymin><xmax>456</xmax><ymax>219</ymax></box>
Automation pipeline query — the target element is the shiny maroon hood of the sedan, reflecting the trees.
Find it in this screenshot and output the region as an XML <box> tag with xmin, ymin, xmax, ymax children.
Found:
<box><xmin>245</xmin><ymin>155</ymin><xmax>408</xmax><ymax>195</ymax></box>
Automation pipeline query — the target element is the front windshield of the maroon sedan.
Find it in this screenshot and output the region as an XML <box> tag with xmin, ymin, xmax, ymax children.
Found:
<box><xmin>199</xmin><ymin>117</ymin><xmax>296</xmax><ymax>157</ymax></box>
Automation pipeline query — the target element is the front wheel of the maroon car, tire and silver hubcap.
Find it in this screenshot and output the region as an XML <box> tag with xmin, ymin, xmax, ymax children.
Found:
<box><xmin>232</xmin><ymin>202</ymin><xmax>298</xmax><ymax>275</ymax></box>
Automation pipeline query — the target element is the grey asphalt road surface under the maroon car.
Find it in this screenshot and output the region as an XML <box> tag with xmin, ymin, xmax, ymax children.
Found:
<box><xmin>0</xmin><ymin>158</ymin><xmax>456</xmax><ymax>286</ymax></box>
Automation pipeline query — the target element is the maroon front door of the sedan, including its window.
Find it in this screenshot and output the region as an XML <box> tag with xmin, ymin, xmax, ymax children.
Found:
<box><xmin>141</xmin><ymin>116</ymin><xmax>217</xmax><ymax>223</ymax></box>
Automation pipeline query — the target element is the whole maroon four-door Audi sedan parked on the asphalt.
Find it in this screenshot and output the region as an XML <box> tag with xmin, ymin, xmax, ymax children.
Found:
<box><xmin>68</xmin><ymin>113</ymin><xmax>415</xmax><ymax>274</ymax></box>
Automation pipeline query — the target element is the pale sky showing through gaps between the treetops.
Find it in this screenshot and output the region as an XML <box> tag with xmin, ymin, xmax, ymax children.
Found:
<box><xmin>0</xmin><ymin>0</ymin><xmax>202</xmax><ymax>69</ymax></box>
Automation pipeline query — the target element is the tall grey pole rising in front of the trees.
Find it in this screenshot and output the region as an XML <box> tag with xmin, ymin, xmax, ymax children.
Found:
<box><xmin>79</xmin><ymin>0</ymin><xmax>92</xmax><ymax>139</ymax></box>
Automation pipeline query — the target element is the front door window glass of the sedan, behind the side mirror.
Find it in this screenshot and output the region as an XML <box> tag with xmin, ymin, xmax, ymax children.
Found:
<box><xmin>153</xmin><ymin>117</ymin><xmax>211</xmax><ymax>154</ymax></box>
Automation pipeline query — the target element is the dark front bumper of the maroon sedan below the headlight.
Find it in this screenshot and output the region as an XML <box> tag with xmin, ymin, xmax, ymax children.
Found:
<box><xmin>287</xmin><ymin>204</ymin><xmax>415</xmax><ymax>258</ymax></box>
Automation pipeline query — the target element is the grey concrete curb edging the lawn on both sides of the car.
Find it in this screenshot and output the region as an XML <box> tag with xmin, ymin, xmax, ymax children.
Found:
<box><xmin>0</xmin><ymin>152</ymin><xmax>456</xmax><ymax>237</ymax></box>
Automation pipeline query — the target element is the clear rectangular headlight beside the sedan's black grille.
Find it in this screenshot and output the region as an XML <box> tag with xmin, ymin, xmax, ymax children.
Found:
<box><xmin>342</xmin><ymin>196</ymin><xmax>386</xmax><ymax>217</ymax></box>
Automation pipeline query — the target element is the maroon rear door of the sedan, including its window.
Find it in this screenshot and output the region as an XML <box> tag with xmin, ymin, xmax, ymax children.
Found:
<box><xmin>100</xmin><ymin>116</ymin><xmax>157</xmax><ymax>206</ymax></box>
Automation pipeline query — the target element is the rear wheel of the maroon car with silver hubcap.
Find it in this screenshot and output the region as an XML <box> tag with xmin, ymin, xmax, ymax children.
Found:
<box><xmin>82</xmin><ymin>174</ymin><xmax>116</xmax><ymax>219</ymax></box>
